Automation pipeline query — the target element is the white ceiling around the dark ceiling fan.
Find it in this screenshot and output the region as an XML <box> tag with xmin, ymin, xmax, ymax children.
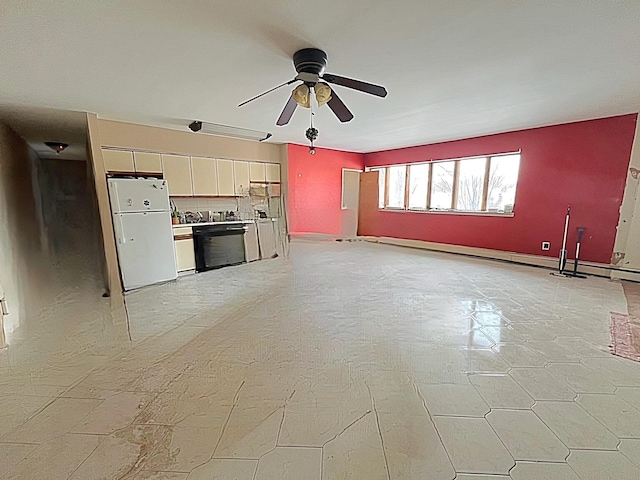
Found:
<box><xmin>0</xmin><ymin>0</ymin><xmax>640</xmax><ymax>152</ymax></box>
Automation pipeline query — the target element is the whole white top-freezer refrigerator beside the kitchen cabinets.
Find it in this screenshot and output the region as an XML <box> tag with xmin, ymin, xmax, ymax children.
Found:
<box><xmin>108</xmin><ymin>178</ymin><xmax>178</xmax><ymax>290</ymax></box>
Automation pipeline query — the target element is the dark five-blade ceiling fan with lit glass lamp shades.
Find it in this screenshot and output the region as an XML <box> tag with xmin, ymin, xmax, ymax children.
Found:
<box><xmin>238</xmin><ymin>48</ymin><xmax>387</xmax><ymax>125</ymax></box>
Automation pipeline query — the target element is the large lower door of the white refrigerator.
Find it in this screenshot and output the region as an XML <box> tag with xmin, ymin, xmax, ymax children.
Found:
<box><xmin>113</xmin><ymin>212</ymin><xmax>177</xmax><ymax>290</ymax></box>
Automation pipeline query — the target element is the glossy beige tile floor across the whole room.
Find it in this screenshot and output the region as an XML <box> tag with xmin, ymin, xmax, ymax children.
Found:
<box><xmin>0</xmin><ymin>241</ymin><xmax>640</xmax><ymax>480</ymax></box>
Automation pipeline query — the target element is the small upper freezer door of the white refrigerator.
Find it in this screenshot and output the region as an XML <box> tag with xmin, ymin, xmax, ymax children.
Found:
<box><xmin>108</xmin><ymin>178</ymin><xmax>170</xmax><ymax>213</ymax></box>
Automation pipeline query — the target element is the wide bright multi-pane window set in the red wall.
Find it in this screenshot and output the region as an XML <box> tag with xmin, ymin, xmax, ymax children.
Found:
<box><xmin>371</xmin><ymin>153</ymin><xmax>520</xmax><ymax>213</ymax></box>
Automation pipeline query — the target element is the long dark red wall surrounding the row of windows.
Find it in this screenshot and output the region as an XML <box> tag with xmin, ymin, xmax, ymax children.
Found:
<box><xmin>358</xmin><ymin>114</ymin><xmax>637</xmax><ymax>263</ymax></box>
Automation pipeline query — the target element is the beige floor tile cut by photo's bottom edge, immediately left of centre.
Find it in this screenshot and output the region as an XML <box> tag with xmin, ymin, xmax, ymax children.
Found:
<box><xmin>255</xmin><ymin>447</ymin><xmax>322</xmax><ymax>480</ymax></box>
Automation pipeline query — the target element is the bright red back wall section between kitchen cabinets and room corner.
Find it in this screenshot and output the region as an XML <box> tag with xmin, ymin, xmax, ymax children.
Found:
<box><xmin>287</xmin><ymin>144</ymin><xmax>364</xmax><ymax>235</ymax></box>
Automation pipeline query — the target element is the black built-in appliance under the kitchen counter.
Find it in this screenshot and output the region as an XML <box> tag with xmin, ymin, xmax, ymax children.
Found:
<box><xmin>193</xmin><ymin>223</ymin><xmax>246</xmax><ymax>272</ymax></box>
